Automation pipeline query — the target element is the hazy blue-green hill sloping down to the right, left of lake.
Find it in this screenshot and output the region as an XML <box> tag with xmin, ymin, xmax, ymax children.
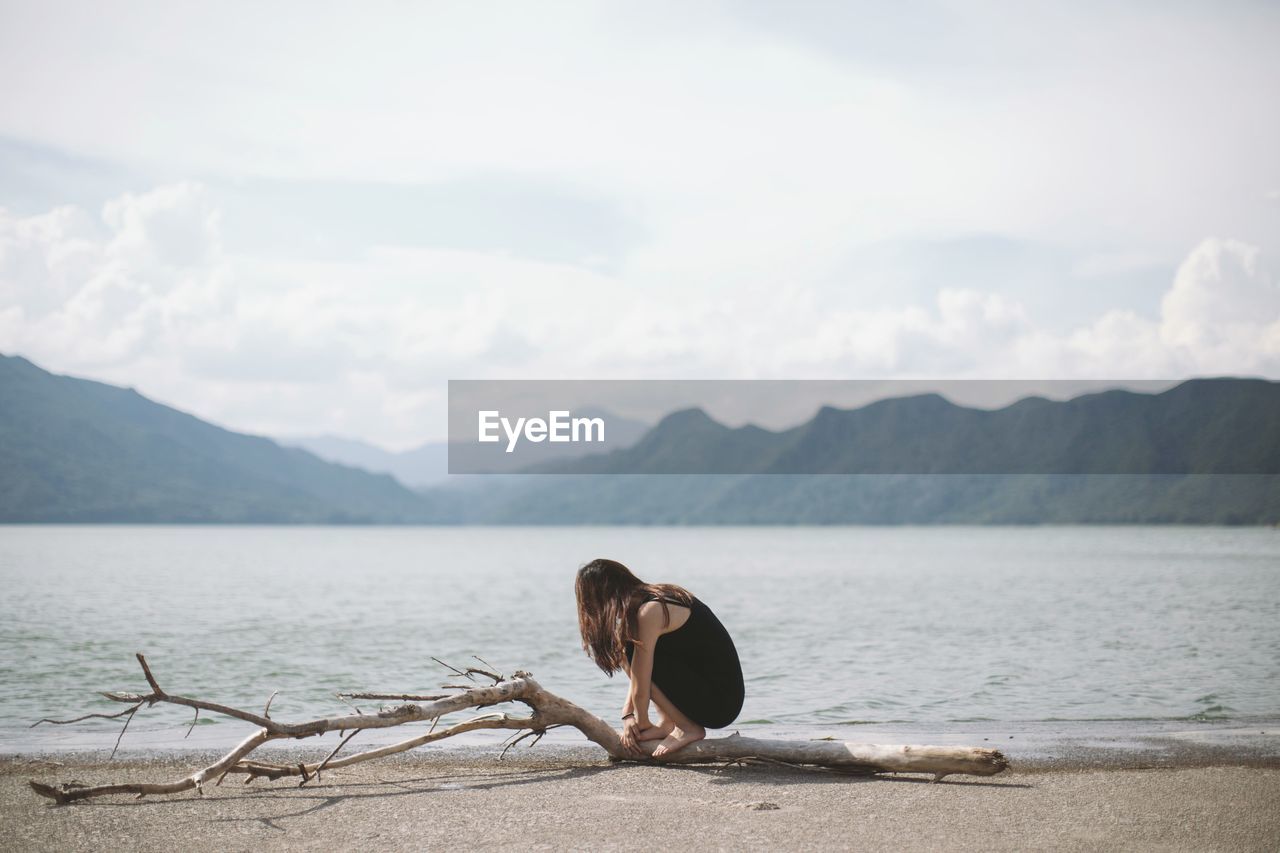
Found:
<box><xmin>0</xmin><ymin>356</ymin><xmax>431</xmax><ymax>524</ymax></box>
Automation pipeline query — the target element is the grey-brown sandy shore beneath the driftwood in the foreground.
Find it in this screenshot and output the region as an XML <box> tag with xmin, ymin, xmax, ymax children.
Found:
<box><xmin>0</xmin><ymin>749</ymin><xmax>1280</xmax><ymax>850</ymax></box>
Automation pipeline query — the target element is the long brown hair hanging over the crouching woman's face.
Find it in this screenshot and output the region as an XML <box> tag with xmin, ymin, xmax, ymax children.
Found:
<box><xmin>573</xmin><ymin>557</ymin><xmax>694</xmax><ymax>675</ymax></box>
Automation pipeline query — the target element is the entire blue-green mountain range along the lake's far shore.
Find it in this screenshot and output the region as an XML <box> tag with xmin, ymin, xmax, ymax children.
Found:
<box><xmin>0</xmin><ymin>356</ymin><xmax>1280</xmax><ymax>524</ymax></box>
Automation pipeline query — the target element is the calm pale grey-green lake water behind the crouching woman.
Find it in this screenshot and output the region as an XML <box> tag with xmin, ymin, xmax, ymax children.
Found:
<box><xmin>0</xmin><ymin>517</ymin><xmax>1280</xmax><ymax>752</ymax></box>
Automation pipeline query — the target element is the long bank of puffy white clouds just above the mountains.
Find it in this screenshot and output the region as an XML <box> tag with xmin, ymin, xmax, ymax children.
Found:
<box><xmin>0</xmin><ymin>183</ymin><xmax>1280</xmax><ymax>446</ymax></box>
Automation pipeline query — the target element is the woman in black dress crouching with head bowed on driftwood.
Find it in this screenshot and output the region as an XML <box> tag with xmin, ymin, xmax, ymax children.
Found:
<box><xmin>576</xmin><ymin>560</ymin><xmax>742</xmax><ymax>758</ymax></box>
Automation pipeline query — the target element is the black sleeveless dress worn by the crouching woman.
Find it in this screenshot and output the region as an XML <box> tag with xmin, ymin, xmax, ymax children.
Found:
<box><xmin>626</xmin><ymin>596</ymin><xmax>745</xmax><ymax>729</ymax></box>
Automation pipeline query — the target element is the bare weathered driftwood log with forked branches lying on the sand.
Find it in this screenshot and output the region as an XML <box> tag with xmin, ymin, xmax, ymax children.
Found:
<box><xmin>29</xmin><ymin>654</ymin><xmax>1009</xmax><ymax>803</ymax></box>
